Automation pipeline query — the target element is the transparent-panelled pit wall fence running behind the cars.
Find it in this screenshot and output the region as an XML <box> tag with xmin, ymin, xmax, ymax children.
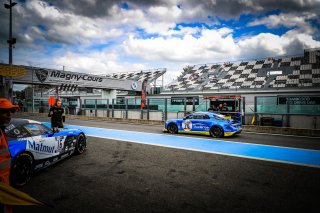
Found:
<box><xmin>22</xmin><ymin>97</ymin><xmax>320</xmax><ymax>129</ymax></box>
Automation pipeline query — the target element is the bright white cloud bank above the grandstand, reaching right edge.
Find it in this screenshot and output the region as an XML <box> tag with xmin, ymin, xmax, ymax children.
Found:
<box><xmin>123</xmin><ymin>25</ymin><xmax>320</xmax><ymax>64</ymax></box>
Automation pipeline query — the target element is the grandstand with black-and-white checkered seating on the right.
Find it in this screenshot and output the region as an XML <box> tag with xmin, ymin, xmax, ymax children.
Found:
<box><xmin>162</xmin><ymin>48</ymin><xmax>320</xmax><ymax>94</ymax></box>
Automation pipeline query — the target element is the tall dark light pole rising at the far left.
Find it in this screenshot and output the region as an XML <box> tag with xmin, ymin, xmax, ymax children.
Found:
<box><xmin>4</xmin><ymin>0</ymin><xmax>17</xmax><ymax>101</ymax></box>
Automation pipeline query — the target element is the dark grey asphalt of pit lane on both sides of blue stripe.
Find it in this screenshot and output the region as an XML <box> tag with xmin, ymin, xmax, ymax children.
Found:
<box><xmin>14</xmin><ymin>117</ymin><xmax>320</xmax><ymax>212</ymax></box>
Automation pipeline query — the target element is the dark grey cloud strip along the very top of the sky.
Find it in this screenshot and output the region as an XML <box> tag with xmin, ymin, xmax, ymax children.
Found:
<box><xmin>42</xmin><ymin>0</ymin><xmax>320</xmax><ymax>20</ymax></box>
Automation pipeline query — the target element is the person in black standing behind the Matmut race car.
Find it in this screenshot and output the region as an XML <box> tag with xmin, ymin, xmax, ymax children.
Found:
<box><xmin>48</xmin><ymin>99</ymin><xmax>65</xmax><ymax>131</ymax></box>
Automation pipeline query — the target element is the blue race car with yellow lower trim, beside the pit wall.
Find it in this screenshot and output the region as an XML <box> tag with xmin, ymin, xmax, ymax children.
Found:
<box><xmin>164</xmin><ymin>112</ymin><xmax>242</xmax><ymax>137</ymax></box>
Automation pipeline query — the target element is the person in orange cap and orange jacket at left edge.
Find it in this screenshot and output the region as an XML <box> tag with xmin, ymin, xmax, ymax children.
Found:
<box><xmin>0</xmin><ymin>98</ymin><xmax>19</xmax><ymax>213</ymax></box>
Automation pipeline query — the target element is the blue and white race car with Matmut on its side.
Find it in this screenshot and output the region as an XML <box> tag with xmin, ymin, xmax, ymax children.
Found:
<box><xmin>5</xmin><ymin>119</ymin><xmax>86</xmax><ymax>187</ymax></box>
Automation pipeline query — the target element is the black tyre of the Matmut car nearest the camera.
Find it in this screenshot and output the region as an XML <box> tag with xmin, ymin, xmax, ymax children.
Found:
<box><xmin>10</xmin><ymin>152</ymin><xmax>34</xmax><ymax>187</ymax></box>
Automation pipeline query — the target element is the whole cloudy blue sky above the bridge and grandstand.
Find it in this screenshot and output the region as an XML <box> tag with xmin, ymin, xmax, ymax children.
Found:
<box><xmin>0</xmin><ymin>0</ymin><xmax>320</xmax><ymax>82</ymax></box>
